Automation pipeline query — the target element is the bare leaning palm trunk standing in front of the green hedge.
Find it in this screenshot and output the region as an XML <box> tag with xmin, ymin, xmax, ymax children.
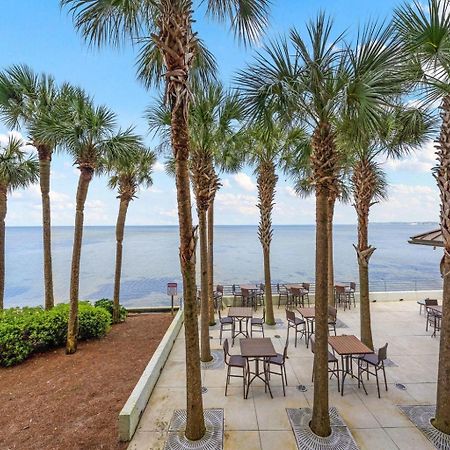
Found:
<box><xmin>66</xmin><ymin>168</ymin><xmax>93</xmax><ymax>354</ymax></box>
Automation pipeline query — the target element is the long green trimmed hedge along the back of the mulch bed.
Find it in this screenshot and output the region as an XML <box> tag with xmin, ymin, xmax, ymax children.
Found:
<box><xmin>0</xmin><ymin>302</ymin><xmax>111</xmax><ymax>367</ymax></box>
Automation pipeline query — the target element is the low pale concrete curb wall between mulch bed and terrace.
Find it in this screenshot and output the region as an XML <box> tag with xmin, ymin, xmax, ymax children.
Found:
<box><xmin>119</xmin><ymin>310</ymin><xmax>184</xmax><ymax>441</ymax></box>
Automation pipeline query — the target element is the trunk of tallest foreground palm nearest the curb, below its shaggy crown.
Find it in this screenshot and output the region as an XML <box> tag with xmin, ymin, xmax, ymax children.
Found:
<box><xmin>172</xmin><ymin>107</ymin><xmax>206</xmax><ymax>441</ymax></box>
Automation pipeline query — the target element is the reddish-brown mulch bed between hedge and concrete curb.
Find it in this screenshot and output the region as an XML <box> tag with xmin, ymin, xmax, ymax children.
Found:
<box><xmin>0</xmin><ymin>314</ymin><xmax>172</xmax><ymax>450</ymax></box>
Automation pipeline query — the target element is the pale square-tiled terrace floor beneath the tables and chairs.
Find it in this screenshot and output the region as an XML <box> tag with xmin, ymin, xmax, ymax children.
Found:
<box><xmin>128</xmin><ymin>302</ymin><xmax>439</xmax><ymax>450</ymax></box>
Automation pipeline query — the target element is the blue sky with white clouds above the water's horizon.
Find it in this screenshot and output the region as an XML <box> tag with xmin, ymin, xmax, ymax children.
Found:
<box><xmin>0</xmin><ymin>0</ymin><xmax>439</xmax><ymax>226</ymax></box>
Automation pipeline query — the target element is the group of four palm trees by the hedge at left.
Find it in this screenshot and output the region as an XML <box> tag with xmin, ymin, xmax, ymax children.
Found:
<box><xmin>0</xmin><ymin>66</ymin><xmax>156</xmax><ymax>353</ymax></box>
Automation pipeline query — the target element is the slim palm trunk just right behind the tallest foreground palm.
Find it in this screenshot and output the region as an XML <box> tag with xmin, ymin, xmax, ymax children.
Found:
<box><xmin>198</xmin><ymin>209</ymin><xmax>212</xmax><ymax>362</ymax></box>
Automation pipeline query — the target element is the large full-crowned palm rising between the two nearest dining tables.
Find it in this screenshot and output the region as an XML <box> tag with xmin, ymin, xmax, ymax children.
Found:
<box><xmin>238</xmin><ymin>14</ymin><xmax>402</xmax><ymax>436</ymax></box>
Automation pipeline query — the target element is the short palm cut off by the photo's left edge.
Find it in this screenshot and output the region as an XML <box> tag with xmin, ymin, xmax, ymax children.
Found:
<box><xmin>0</xmin><ymin>136</ymin><xmax>39</xmax><ymax>311</ymax></box>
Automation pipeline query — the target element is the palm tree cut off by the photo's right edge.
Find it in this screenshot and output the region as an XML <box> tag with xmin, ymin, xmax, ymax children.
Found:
<box><xmin>394</xmin><ymin>0</ymin><xmax>450</xmax><ymax>434</ymax></box>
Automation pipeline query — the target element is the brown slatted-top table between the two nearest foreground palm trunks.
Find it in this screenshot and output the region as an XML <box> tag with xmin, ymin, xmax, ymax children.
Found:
<box><xmin>240</xmin><ymin>338</ymin><xmax>277</xmax><ymax>398</ymax></box>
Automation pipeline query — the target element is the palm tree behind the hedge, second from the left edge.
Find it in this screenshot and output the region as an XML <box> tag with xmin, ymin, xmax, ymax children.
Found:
<box><xmin>0</xmin><ymin>66</ymin><xmax>58</xmax><ymax>309</ymax></box>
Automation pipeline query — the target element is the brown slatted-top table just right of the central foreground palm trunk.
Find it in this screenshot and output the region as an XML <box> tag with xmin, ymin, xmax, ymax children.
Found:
<box><xmin>328</xmin><ymin>335</ymin><xmax>373</xmax><ymax>395</ymax></box>
